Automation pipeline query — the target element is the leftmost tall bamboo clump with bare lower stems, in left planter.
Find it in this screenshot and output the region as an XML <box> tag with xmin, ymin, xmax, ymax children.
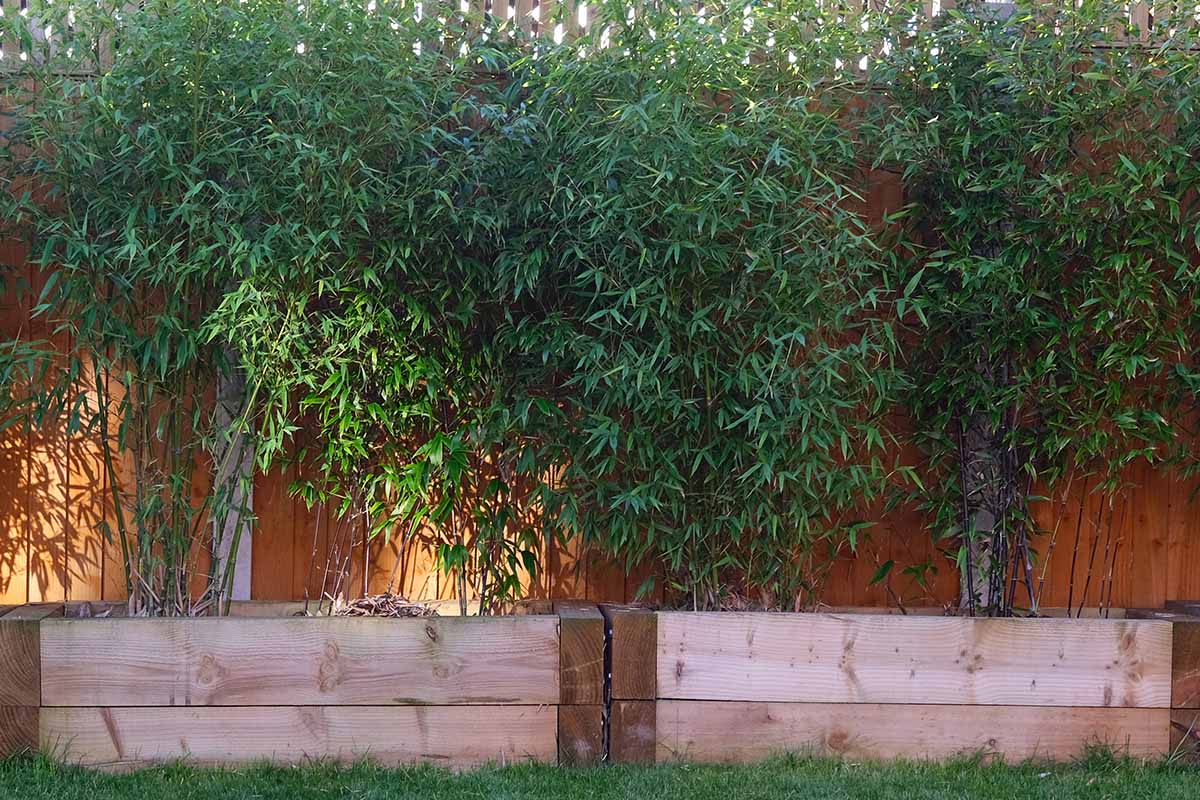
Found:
<box><xmin>2</xmin><ymin>6</ymin><xmax>267</xmax><ymax>614</ymax></box>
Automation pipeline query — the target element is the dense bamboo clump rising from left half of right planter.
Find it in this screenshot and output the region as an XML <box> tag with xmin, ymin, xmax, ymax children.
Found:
<box><xmin>511</xmin><ymin>6</ymin><xmax>888</xmax><ymax>606</ymax></box>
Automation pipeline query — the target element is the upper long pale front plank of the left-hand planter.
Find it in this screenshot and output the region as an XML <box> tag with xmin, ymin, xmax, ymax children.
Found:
<box><xmin>42</xmin><ymin>616</ymin><xmax>558</xmax><ymax>705</ymax></box>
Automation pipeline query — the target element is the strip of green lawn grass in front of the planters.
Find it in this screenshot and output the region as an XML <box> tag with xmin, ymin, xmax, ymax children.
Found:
<box><xmin>0</xmin><ymin>756</ymin><xmax>1200</xmax><ymax>800</ymax></box>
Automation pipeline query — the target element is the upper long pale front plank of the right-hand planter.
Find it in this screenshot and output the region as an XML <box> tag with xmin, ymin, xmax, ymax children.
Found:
<box><xmin>658</xmin><ymin>613</ymin><xmax>1171</xmax><ymax>708</ymax></box>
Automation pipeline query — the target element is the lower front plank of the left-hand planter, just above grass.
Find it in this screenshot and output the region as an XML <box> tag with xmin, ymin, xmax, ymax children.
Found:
<box><xmin>40</xmin><ymin>705</ymin><xmax>557</xmax><ymax>769</ymax></box>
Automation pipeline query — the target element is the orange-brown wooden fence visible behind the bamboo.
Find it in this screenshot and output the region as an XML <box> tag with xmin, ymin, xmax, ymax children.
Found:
<box><xmin>0</xmin><ymin>0</ymin><xmax>1200</xmax><ymax>607</ymax></box>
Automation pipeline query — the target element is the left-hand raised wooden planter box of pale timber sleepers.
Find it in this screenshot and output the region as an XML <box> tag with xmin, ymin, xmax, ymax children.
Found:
<box><xmin>0</xmin><ymin>607</ymin><xmax>604</xmax><ymax>769</ymax></box>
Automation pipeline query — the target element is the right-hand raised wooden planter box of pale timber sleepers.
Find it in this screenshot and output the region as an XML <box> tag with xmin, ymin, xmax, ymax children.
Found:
<box><xmin>610</xmin><ymin>612</ymin><xmax>1200</xmax><ymax>762</ymax></box>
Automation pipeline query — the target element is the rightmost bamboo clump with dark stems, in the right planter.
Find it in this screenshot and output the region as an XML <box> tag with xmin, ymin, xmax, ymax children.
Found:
<box><xmin>868</xmin><ymin>4</ymin><xmax>1200</xmax><ymax>613</ymax></box>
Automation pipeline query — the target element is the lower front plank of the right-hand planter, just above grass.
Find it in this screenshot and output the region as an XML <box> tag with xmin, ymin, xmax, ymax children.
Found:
<box><xmin>656</xmin><ymin>700</ymin><xmax>1171</xmax><ymax>762</ymax></box>
